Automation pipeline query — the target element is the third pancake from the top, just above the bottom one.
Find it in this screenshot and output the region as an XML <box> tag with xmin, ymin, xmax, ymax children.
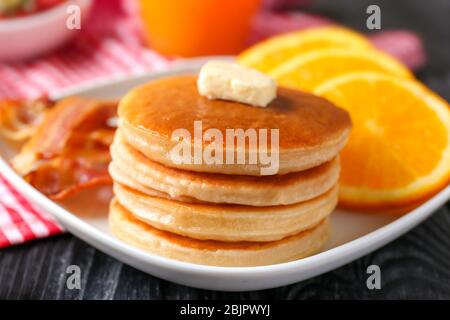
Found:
<box><xmin>114</xmin><ymin>183</ymin><xmax>338</xmax><ymax>241</ymax></box>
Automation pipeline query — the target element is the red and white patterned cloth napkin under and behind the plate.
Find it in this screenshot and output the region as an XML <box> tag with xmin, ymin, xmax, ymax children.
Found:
<box><xmin>0</xmin><ymin>0</ymin><xmax>424</xmax><ymax>248</ymax></box>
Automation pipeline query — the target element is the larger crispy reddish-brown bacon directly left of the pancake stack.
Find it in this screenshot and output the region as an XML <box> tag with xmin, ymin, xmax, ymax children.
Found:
<box><xmin>12</xmin><ymin>97</ymin><xmax>117</xmax><ymax>200</ymax></box>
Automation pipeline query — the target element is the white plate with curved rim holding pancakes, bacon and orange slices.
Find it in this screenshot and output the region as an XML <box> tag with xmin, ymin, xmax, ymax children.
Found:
<box><xmin>0</xmin><ymin>60</ymin><xmax>450</xmax><ymax>291</ymax></box>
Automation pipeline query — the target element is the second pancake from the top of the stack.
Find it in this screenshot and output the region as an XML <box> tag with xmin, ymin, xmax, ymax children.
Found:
<box><xmin>109</xmin><ymin>130</ymin><xmax>339</xmax><ymax>206</ymax></box>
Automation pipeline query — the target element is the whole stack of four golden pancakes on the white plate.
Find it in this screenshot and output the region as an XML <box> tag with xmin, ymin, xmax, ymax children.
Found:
<box><xmin>109</xmin><ymin>75</ymin><xmax>351</xmax><ymax>266</ymax></box>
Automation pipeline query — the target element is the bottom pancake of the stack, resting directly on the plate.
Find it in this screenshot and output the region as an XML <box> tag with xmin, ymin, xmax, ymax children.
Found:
<box><xmin>109</xmin><ymin>200</ymin><xmax>329</xmax><ymax>267</ymax></box>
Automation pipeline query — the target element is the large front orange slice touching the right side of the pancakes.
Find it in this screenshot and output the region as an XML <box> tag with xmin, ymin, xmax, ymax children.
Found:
<box><xmin>314</xmin><ymin>73</ymin><xmax>450</xmax><ymax>208</ymax></box>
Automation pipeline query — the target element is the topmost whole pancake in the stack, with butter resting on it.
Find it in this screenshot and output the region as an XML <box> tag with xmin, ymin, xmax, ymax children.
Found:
<box><xmin>118</xmin><ymin>75</ymin><xmax>351</xmax><ymax>175</ymax></box>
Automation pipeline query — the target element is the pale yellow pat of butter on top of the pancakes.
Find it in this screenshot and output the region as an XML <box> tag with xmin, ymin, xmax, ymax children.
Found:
<box><xmin>197</xmin><ymin>60</ymin><xmax>277</xmax><ymax>107</ymax></box>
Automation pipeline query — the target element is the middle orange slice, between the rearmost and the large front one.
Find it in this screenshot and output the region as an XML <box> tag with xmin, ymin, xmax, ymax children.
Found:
<box><xmin>269</xmin><ymin>48</ymin><xmax>414</xmax><ymax>91</ymax></box>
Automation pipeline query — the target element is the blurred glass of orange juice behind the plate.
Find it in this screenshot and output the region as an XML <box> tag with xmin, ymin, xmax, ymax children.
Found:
<box><xmin>140</xmin><ymin>0</ymin><xmax>261</xmax><ymax>57</ymax></box>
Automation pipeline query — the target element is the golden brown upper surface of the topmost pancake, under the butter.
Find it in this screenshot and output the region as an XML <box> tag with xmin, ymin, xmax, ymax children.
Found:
<box><xmin>119</xmin><ymin>75</ymin><xmax>351</xmax><ymax>149</ymax></box>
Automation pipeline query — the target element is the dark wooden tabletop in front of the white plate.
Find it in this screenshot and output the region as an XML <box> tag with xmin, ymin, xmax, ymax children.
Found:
<box><xmin>0</xmin><ymin>207</ymin><xmax>450</xmax><ymax>300</ymax></box>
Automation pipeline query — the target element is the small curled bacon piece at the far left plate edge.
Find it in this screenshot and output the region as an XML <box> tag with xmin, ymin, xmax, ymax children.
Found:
<box><xmin>0</xmin><ymin>98</ymin><xmax>55</xmax><ymax>141</ymax></box>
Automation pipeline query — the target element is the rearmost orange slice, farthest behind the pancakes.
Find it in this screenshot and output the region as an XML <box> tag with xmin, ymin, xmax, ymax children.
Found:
<box><xmin>237</xmin><ymin>27</ymin><xmax>372</xmax><ymax>72</ymax></box>
